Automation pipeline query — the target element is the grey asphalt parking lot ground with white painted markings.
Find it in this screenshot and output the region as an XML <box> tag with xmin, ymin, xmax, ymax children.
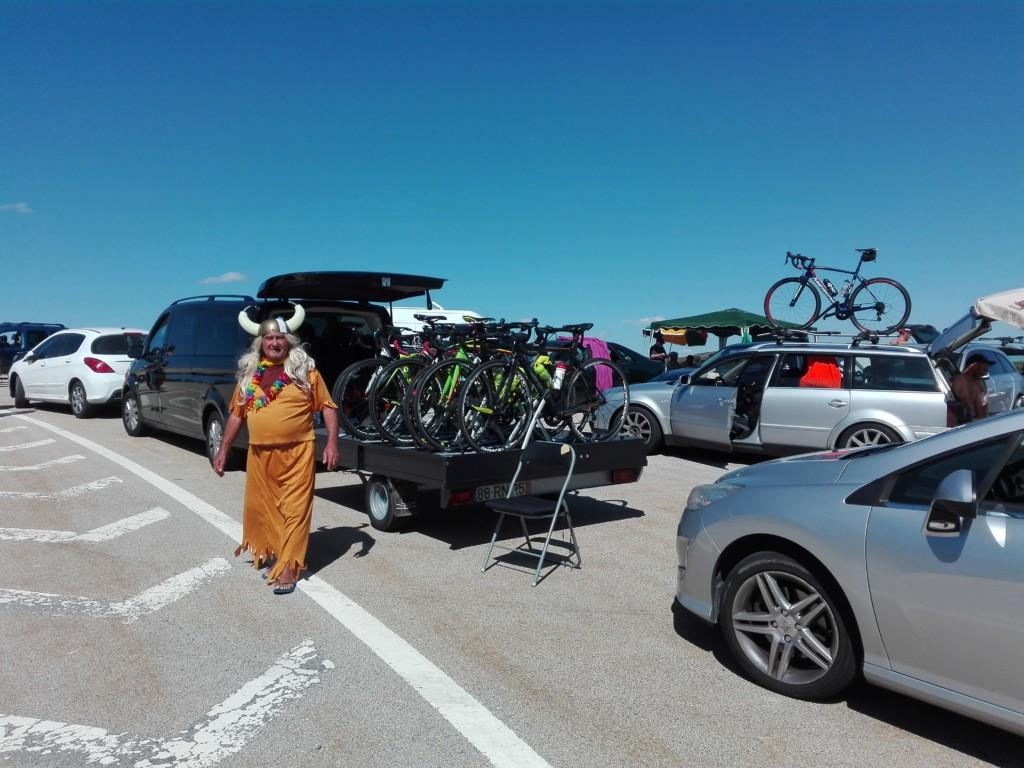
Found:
<box><xmin>0</xmin><ymin>389</ymin><xmax>1024</xmax><ymax>768</ymax></box>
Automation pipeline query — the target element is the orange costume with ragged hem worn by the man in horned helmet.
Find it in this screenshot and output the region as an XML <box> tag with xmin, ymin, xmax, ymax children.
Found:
<box><xmin>231</xmin><ymin>369</ymin><xmax>338</xmax><ymax>582</ymax></box>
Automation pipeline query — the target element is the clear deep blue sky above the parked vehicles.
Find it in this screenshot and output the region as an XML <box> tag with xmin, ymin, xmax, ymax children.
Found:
<box><xmin>0</xmin><ymin>0</ymin><xmax>1024</xmax><ymax>348</ymax></box>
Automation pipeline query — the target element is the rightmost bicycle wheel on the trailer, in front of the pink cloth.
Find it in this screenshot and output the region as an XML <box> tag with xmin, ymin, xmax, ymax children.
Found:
<box><xmin>560</xmin><ymin>358</ymin><xmax>630</xmax><ymax>442</ymax></box>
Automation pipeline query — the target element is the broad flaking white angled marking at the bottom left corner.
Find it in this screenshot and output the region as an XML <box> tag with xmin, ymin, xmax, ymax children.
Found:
<box><xmin>0</xmin><ymin>640</ymin><xmax>323</xmax><ymax>768</ymax></box>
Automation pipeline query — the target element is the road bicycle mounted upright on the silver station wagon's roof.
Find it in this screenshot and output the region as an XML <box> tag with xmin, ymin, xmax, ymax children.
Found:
<box><xmin>765</xmin><ymin>248</ymin><xmax>910</xmax><ymax>335</ymax></box>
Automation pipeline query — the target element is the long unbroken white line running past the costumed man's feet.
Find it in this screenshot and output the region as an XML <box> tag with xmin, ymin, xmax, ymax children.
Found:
<box><xmin>14</xmin><ymin>416</ymin><xmax>551</xmax><ymax>768</ymax></box>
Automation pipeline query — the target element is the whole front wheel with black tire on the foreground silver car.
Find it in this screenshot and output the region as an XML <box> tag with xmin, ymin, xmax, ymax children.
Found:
<box><xmin>720</xmin><ymin>552</ymin><xmax>858</xmax><ymax>699</ymax></box>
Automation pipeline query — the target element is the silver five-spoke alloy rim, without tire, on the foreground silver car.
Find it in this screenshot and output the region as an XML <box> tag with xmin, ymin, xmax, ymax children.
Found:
<box><xmin>731</xmin><ymin>570</ymin><xmax>840</xmax><ymax>685</ymax></box>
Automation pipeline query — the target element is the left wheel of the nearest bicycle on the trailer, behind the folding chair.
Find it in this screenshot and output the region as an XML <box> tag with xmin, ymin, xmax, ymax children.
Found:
<box><xmin>458</xmin><ymin>360</ymin><xmax>535</xmax><ymax>454</ymax></box>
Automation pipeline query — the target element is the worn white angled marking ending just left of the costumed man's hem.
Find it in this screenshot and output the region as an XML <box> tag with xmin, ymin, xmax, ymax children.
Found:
<box><xmin>0</xmin><ymin>557</ymin><xmax>231</xmax><ymax>624</ymax></box>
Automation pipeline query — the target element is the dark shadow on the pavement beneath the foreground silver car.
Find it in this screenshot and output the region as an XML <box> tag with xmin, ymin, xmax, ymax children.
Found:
<box><xmin>672</xmin><ymin>603</ymin><xmax>1024</xmax><ymax>768</ymax></box>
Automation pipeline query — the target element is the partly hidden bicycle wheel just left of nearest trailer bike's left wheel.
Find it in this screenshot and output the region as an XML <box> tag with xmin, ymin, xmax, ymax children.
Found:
<box><xmin>406</xmin><ymin>357</ymin><xmax>474</xmax><ymax>451</ymax></box>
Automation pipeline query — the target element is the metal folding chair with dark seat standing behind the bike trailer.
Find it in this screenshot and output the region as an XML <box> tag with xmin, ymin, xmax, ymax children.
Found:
<box><xmin>480</xmin><ymin>440</ymin><xmax>583</xmax><ymax>587</ymax></box>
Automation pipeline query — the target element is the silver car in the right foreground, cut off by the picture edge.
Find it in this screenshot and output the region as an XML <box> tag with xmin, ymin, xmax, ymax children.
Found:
<box><xmin>676</xmin><ymin>410</ymin><xmax>1024</xmax><ymax>734</ymax></box>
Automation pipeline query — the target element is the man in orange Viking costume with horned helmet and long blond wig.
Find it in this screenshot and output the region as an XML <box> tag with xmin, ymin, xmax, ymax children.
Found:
<box><xmin>213</xmin><ymin>304</ymin><xmax>338</xmax><ymax>595</ymax></box>
